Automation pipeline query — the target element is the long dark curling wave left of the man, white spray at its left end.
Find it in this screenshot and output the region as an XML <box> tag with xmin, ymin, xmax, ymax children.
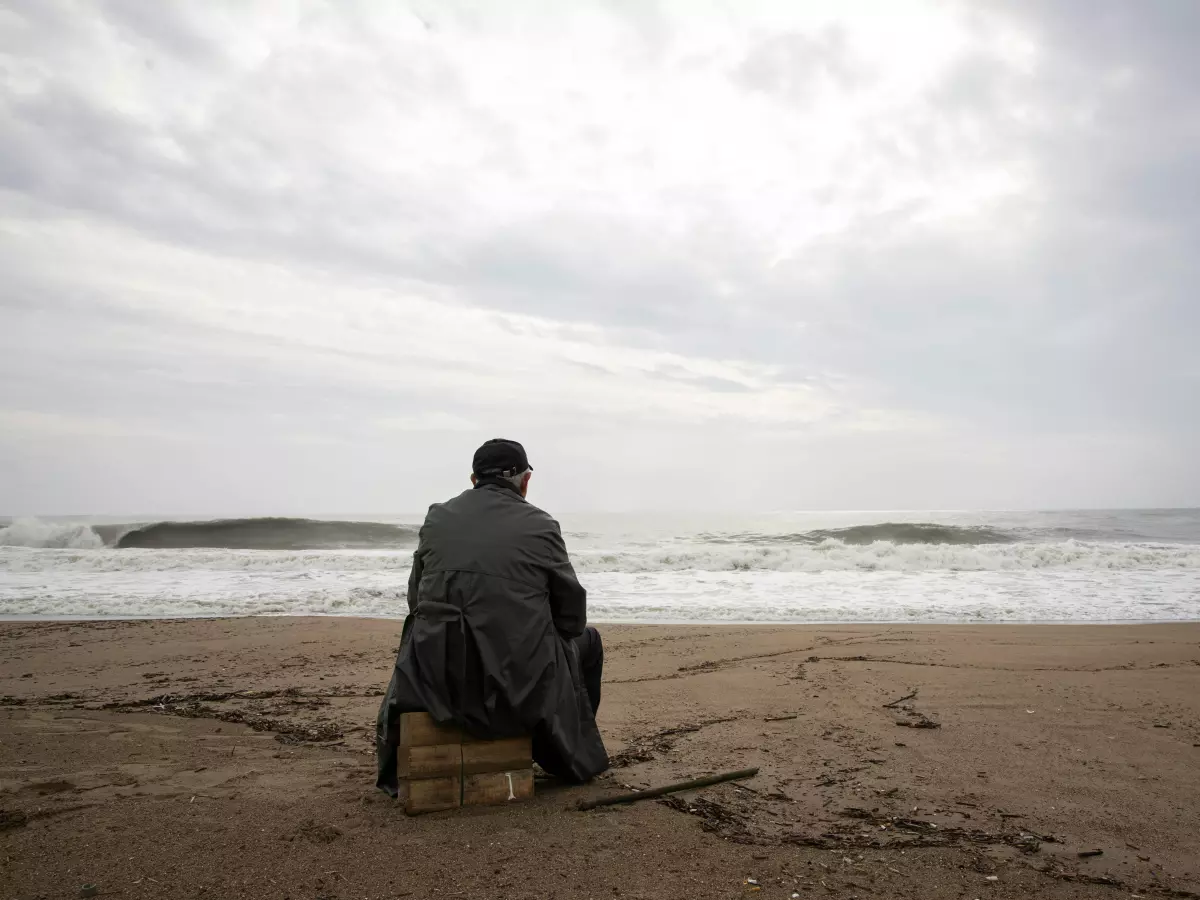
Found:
<box><xmin>0</xmin><ymin>517</ymin><xmax>416</xmax><ymax>550</ymax></box>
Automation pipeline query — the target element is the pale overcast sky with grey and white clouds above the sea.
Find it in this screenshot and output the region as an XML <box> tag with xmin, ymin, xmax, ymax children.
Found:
<box><xmin>0</xmin><ymin>0</ymin><xmax>1200</xmax><ymax>515</ymax></box>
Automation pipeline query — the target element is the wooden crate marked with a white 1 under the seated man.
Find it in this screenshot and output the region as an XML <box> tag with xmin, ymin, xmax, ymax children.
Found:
<box><xmin>397</xmin><ymin>713</ymin><xmax>533</xmax><ymax>816</ymax></box>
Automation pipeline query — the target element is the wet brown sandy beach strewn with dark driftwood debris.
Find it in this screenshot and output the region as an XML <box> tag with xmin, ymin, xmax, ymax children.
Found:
<box><xmin>0</xmin><ymin>618</ymin><xmax>1200</xmax><ymax>900</ymax></box>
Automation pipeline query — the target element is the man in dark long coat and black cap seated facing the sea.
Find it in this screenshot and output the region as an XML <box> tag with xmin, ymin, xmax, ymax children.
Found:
<box><xmin>376</xmin><ymin>439</ymin><xmax>608</xmax><ymax>796</ymax></box>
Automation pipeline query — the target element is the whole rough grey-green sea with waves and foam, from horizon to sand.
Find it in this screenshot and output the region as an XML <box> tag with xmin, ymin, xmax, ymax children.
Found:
<box><xmin>0</xmin><ymin>509</ymin><xmax>1200</xmax><ymax>623</ymax></box>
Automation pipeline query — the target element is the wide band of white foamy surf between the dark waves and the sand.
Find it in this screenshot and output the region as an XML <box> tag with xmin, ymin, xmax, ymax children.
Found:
<box><xmin>0</xmin><ymin>541</ymin><xmax>1200</xmax><ymax>622</ymax></box>
